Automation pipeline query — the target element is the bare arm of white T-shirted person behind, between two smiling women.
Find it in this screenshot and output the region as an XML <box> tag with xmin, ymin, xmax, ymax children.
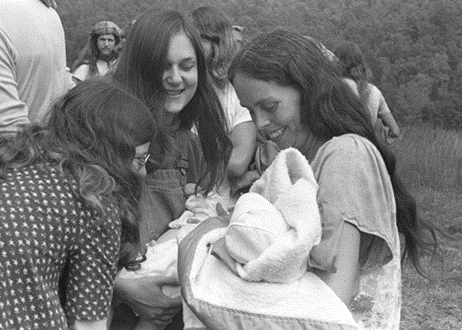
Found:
<box><xmin>228</xmin><ymin>121</ymin><xmax>257</xmax><ymax>177</ymax></box>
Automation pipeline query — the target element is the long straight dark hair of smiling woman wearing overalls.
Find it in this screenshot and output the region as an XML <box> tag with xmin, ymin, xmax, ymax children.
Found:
<box><xmin>113</xmin><ymin>9</ymin><xmax>231</xmax><ymax>192</ymax></box>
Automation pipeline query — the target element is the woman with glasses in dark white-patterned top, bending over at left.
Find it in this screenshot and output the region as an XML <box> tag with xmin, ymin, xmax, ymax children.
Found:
<box><xmin>0</xmin><ymin>81</ymin><xmax>157</xmax><ymax>330</ymax></box>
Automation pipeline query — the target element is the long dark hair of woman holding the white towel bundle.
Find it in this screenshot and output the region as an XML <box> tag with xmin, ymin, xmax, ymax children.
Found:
<box><xmin>229</xmin><ymin>29</ymin><xmax>437</xmax><ymax>275</ymax></box>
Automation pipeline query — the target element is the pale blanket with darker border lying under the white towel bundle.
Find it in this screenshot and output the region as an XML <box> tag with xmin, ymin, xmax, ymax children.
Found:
<box><xmin>181</xmin><ymin>228</ymin><xmax>357</xmax><ymax>330</ymax></box>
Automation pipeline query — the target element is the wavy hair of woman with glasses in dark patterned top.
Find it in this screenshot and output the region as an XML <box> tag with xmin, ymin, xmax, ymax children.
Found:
<box><xmin>0</xmin><ymin>80</ymin><xmax>156</xmax><ymax>269</ymax></box>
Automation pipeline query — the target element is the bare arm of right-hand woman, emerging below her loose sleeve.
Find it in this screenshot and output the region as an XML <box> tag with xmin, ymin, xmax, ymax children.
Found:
<box><xmin>314</xmin><ymin>223</ymin><xmax>360</xmax><ymax>306</ymax></box>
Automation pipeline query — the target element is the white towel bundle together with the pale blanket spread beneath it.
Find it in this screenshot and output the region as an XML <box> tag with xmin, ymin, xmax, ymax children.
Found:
<box><xmin>181</xmin><ymin>149</ymin><xmax>357</xmax><ymax>330</ymax></box>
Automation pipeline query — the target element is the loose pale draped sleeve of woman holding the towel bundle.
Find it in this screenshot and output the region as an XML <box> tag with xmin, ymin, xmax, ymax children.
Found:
<box><xmin>309</xmin><ymin>134</ymin><xmax>399</xmax><ymax>272</ymax></box>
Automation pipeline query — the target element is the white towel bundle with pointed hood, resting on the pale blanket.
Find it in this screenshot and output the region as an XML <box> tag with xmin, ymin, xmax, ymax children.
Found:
<box><xmin>225</xmin><ymin>148</ymin><xmax>321</xmax><ymax>283</ymax></box>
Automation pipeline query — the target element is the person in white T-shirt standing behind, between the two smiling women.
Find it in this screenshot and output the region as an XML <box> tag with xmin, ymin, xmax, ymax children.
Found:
<box><xmin>191</xmin><ymin>6</ymin><xmax>256</xmax><ymax>204</ymax></box>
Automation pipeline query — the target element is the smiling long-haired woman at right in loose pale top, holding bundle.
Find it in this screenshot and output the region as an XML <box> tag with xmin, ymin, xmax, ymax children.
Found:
<box><xmin>178</xmin><ymin>29</ymin><xmax>437</xmax><ymax>330</ymax></box>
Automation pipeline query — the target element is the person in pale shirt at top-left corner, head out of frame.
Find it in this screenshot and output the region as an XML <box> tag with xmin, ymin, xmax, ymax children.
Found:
<box><xmin>0</xmin><ymin>0</ymin><xmax>75</xmax><ymax>134</ymax></box>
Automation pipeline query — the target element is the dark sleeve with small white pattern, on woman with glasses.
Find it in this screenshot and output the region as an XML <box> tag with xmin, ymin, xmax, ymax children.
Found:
<box><xmin>66</xmin><ymin>204</ymin><xmax>121</xmax><ymax>321</ymax></box>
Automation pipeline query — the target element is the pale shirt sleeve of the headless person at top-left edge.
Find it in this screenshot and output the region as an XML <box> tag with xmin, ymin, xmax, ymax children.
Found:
<box><xmin>0</xmin><ymin>26</ymin><xmax>29</xmax><ymax>131</ymax></box>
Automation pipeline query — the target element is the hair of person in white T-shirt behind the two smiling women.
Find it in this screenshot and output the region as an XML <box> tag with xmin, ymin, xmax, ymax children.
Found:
<box><xmin>191</xmin><ymin>6</ymin><xmax>238</xmax><ymax>89</ymax></box>
